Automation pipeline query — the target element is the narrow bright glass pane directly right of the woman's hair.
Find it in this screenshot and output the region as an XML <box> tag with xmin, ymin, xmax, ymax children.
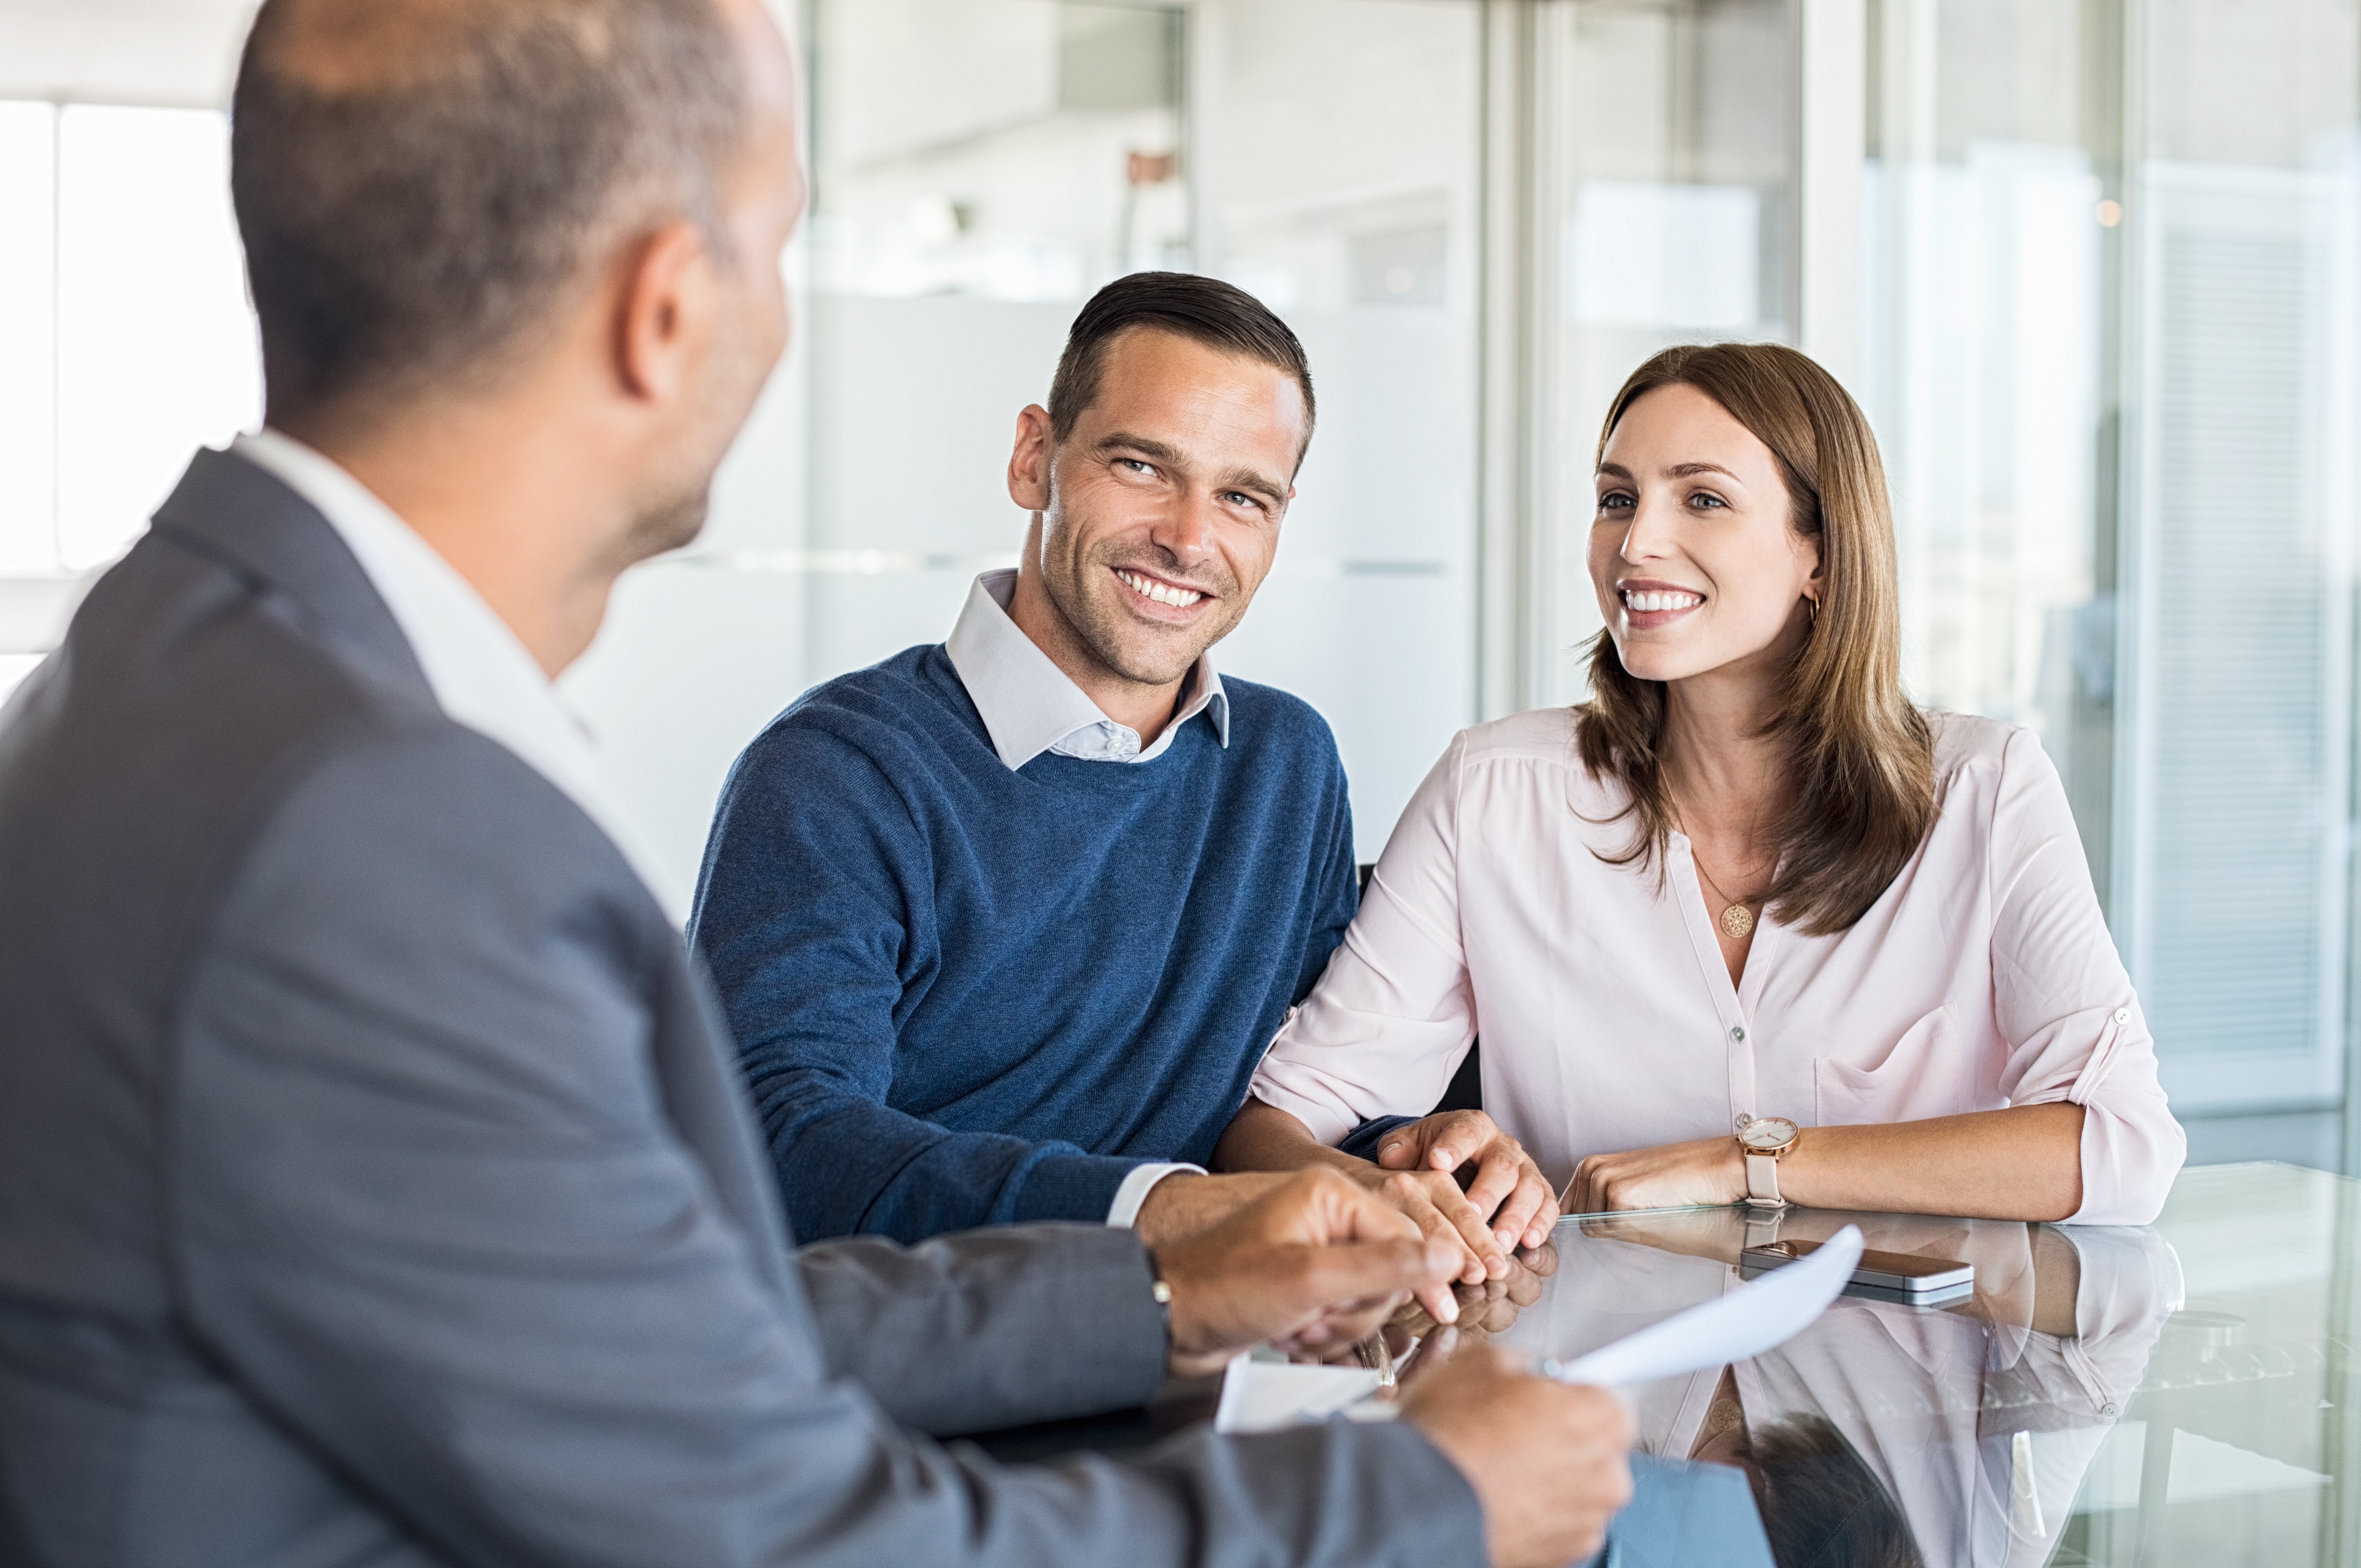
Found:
<box><xmin>1856</xmin><ymin>0</ymin><xmax>2122</xmax><ymax>859</ymax></box>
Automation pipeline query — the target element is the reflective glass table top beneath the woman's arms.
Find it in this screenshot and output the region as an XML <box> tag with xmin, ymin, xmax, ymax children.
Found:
<box><xmin>1494</xmin><ymin>1164</ymin><xmax>2361</xmax><ymax>1568</ymax></box>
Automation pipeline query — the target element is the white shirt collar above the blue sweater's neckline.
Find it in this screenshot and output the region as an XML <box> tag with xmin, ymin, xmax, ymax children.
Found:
<box><xmin>942</xmin><ymin>567</ymin><xmax>1230</xmax><ymax>772</ymax></box>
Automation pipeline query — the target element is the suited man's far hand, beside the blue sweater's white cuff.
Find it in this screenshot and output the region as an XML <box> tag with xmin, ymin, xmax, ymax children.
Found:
<box><xmin>1154</xmin><ymin>1166</ymin><xmax>1459</xmax><ymax>1377</ymax></box>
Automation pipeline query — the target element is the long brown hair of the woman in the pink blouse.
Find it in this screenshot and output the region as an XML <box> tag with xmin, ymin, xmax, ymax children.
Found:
<box><xmin>1575</xmin><ymin>342</ymin><xmax>1934</xmax><ymax>937</ymax></box>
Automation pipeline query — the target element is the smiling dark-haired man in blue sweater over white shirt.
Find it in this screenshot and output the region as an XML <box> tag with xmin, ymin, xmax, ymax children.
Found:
<box><xmin>692</xmin><ymin>272</ymin><xmax>1454</xmax><ymax>1242</ymax></box>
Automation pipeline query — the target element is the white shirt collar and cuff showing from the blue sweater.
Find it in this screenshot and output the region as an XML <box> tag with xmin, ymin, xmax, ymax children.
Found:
<box><xmin>942</xmin><ymin>567</ymin><xmax>1230</xmax><ymax>1226</ymax></box>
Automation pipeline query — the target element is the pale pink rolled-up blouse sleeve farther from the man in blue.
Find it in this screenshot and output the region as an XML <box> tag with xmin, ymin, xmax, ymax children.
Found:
<box><xmin>1988</xmin><ymin>732</ymin><xmax>2188</xmax><ymax>1226</ymax></box>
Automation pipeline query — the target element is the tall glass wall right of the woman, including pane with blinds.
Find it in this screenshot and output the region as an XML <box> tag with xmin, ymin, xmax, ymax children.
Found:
<box><xmin>1860</xmin><ymin>0</ymin><xmax>2361</xmax><ymax>1117</ymax></box>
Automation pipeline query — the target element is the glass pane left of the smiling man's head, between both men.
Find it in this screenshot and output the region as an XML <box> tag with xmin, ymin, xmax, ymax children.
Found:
<box><xmin>803</xmin><ymin>0</ymin><xmax>1195</xmax><ymax>680</ymax></box>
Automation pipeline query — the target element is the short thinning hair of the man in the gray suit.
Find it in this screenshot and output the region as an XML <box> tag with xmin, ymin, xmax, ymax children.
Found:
<box><xmin>229</xmin><ymin>0</ymin><xmax>746</xmax><ymax>413</ymax></box>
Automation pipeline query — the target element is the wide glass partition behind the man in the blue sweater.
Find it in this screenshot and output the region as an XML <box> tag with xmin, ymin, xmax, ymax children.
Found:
<box><xmin>574</xmin><ymin>0</ymin><xmax>1483</xmax><ymax>881</ymax></box>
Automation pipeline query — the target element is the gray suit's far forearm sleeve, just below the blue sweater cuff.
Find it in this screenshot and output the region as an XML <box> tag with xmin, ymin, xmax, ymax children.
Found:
<box><xmin>796</xmin><ymin>1226</ymin><xmax>1166</xmax><ymax>1433</ymax></box>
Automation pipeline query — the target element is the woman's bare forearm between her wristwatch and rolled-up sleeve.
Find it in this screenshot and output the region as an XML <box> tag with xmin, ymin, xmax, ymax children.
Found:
<box><xmin>1778</xmin><ymin>1103</ymin><xmax>2082</xmax><ymax>1221</ymax></box>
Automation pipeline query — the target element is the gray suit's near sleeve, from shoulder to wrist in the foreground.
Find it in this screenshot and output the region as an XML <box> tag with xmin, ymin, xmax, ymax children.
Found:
<box><xmin>174</xmin><ymin>730</ymin><xmax>1483</xmax><ymax>1568</ymax></box>
